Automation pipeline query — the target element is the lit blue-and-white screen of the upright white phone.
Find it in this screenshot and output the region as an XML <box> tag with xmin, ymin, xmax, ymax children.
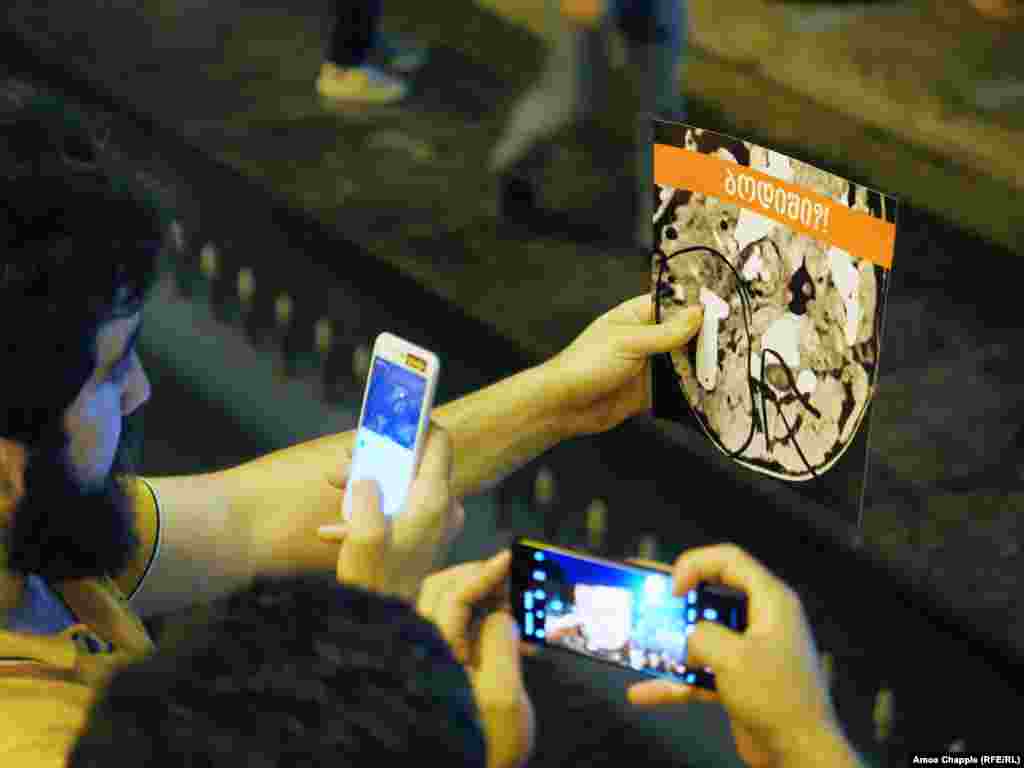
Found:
<box><xmin>345</xmin><ymin>356</ymin><xmax>427</xmax><ymax>517</ymax></box>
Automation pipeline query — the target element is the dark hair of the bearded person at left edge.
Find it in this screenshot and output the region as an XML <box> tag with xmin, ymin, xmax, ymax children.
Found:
<box><xmin>0</xmin><ymin>82</ymin><xmax>173</xmax><ymax>445</ymax></box>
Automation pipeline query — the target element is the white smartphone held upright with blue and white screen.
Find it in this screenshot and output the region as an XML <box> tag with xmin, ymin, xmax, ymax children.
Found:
<box><xmin>342</xmin><ymin>333</ymin><xmax>440</xmax><ymax>520</ymax></box>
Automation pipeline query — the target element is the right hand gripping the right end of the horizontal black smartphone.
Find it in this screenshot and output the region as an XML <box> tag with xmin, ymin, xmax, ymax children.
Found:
<box><xmin>628</xmin><ymin>544</ymin><xmax>846</xmax><ymax>768</ymax></box>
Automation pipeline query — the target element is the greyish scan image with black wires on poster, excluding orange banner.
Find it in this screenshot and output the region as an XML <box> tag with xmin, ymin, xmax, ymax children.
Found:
<box><xmin>651</xmin><ymin>138</ymin><xmax>885</xmax><ymax>481</ymax></box>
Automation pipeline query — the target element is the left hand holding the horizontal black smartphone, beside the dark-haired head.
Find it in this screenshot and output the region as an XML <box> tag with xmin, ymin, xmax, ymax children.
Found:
<box><xmin>417</xmin><ymin>550</ymin><xmax>536</xmax><ymax>768</ymax></box>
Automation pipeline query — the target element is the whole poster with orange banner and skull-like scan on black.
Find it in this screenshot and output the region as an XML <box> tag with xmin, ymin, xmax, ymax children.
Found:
<box><xmin>651</xmin><ymin>121</ymin><xmax>897</xmax><ymax>525</ymax></box>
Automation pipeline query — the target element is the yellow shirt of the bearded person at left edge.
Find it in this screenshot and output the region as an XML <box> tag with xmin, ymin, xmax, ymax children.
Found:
<box><xmin>0</xmin><ymin>478</ymin><xmax>160</xmax><ymax>768</ymax></box>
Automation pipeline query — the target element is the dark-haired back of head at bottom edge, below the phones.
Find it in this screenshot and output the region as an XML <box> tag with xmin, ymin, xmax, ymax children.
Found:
<box><xmin>69</xmin><ymin>575</ymin><xmax>486</xmax><ymax>768</ymax></box>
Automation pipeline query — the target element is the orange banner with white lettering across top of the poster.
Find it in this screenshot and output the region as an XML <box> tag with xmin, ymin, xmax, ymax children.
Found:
<box><xmin>654</xmin><ymin>144</ymin><xmax>896</xmax><ymax>269</ymax></box>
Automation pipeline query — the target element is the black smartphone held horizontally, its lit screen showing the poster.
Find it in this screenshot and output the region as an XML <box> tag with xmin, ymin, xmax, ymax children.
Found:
<box><xmin>510</xmin><ymin>539</ymin><xmax>746</xmax><ymax>690</ymax></box>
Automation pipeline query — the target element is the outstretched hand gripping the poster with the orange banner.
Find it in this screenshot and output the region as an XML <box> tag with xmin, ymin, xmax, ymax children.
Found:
<box><xmin>542</xmin><ymin>294</ymin><xmax>703</xmax><ymax>435</ymax></box>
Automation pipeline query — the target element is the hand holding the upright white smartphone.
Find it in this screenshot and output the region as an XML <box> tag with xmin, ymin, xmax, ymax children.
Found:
<box><xmin>317</xmin><ymin>423</ymin><xmax>466</xmax><ymax>601</ymax></box>
